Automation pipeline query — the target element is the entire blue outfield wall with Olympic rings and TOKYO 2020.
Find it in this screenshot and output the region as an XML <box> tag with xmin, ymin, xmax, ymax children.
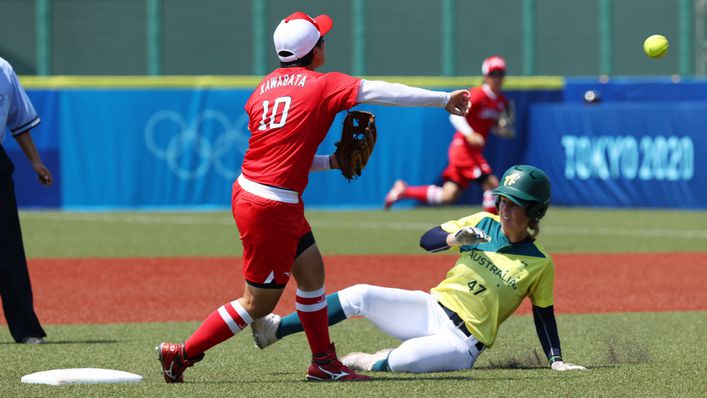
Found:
<box><xmin>15</xmin><ymin>79</ymin><xmax>707</xmax><ymax>209</ymax></box>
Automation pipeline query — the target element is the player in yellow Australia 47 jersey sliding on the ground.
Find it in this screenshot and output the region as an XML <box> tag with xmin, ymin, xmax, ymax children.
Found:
<box><xmin>252</xmin><ymin>165</ymin><xmax>585</xmax><ymax>373</ymax></box>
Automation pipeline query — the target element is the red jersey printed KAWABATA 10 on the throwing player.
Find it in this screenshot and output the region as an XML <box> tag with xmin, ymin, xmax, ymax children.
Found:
<box><xmin>246</xmin><ymin>67</ymin><xmax>361</xmax><ymax>194</ymax></box>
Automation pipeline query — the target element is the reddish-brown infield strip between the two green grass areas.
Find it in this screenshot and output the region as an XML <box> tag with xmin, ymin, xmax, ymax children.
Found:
<box><xmin>0</xmin><ymin>253</ymin><xmax>707</xmax><ymax>324</ymax></box>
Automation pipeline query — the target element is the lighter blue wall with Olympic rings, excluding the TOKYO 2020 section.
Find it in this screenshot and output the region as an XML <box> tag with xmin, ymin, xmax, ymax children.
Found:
<box><xmin>18</xmin><ymin>89</ymin><xmax>561</xmax><ymax>209</ymax></box>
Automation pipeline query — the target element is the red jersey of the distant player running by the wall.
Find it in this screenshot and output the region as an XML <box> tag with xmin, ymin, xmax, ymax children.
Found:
<box><xmin>456</xmin><ymin>85</ymin><xmax>508</xmax><ymax>139</ymax></box>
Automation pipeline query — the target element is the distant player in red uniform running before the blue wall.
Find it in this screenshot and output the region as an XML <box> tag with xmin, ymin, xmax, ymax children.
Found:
<box><xmin>385</xmin><ymin>55</ymin><xmax>509</xmax><ymax>214</ymax></box>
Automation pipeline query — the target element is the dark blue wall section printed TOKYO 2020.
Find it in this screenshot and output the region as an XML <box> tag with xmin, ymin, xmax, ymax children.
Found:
<box><xmin>524</xmin><ymin>102</ymin><xmax>707</xmax><ymax>209</ymax></box>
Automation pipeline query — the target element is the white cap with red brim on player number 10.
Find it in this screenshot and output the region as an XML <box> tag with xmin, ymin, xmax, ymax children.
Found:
<box><xmin>272</xmin><ymin>11</ymin><xmax>334</xmax><ymax>62</ymax></box>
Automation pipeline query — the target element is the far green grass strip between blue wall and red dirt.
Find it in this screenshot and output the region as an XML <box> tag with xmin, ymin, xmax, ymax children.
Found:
<box><xmin>20</xmin><ymin>207</ymin><xmax>707</xmax><ymax>258</ymax></box>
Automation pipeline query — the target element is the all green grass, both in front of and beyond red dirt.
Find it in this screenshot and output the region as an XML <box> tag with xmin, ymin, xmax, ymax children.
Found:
<box><xmin>0</xmin><ymin>207</ymin><xmax>707</xmax><ymax>397</ymax></box>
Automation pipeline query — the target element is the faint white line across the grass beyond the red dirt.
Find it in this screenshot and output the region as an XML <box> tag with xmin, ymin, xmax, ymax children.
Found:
<box><xmin>21</xmin><ymin>212</ymin><xmax>707</xmax><ymax>239</ymax></box>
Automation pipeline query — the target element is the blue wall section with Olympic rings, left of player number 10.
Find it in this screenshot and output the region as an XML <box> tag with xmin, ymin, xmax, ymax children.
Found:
<box><xmin>59</xmin><ymin>89</ymin><xmax>249</xmax><ymax>208</ymax></box>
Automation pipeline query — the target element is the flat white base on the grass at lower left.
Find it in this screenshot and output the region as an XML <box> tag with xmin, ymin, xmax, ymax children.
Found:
<box><xmin>22</xmin><ymin>368</ymin><xmax>142</xmax><ymax>386</ymax></box>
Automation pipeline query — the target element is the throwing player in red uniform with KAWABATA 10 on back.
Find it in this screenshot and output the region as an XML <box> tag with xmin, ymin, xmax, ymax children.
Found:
<box><xmin>157</xmin><ymin>12</ymin><xmax>469</xmax><ymax>383</ymax></box>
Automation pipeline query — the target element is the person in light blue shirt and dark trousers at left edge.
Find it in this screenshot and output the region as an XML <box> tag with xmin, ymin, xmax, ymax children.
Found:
<box><xmin>0</xmin><ymin>58</ymin><xmax>52</xmax><ymax>344</ymax></box>
